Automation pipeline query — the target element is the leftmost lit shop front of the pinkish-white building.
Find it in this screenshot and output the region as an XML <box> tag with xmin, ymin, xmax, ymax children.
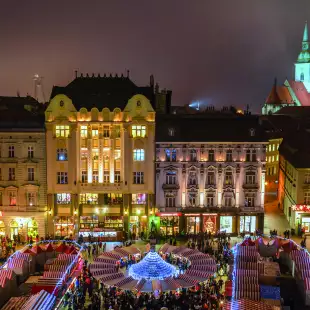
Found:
<box><xmin>156</xmin><ymin>212</ymin><xmax>182</xmax><ymax>237</ymax></box>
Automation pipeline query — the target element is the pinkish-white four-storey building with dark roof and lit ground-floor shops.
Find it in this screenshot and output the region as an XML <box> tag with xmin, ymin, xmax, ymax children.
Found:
<box><xmin>155</xmin><ymin>115</ymin><xmax>268</xmax><ymax>235</ymax></box>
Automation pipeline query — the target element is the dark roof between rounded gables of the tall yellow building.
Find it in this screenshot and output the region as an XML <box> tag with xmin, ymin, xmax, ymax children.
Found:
<box><xmin>51</xmin><ymin>76</ymin><xmax>154</xmax><ymax>110</ymax></box>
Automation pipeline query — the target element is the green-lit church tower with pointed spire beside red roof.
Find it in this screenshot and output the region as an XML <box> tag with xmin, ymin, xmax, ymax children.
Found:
<box><xmin>295</xmin><ymin>22</ymin><xmax>310</xmax><ymax>92</ymax></box>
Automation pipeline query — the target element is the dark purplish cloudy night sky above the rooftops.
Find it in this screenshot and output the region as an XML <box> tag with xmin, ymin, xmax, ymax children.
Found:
<box><xmin>0</xmin><ymin>0</ymin><xmax>310</xmax><ymax>110</ymax></box>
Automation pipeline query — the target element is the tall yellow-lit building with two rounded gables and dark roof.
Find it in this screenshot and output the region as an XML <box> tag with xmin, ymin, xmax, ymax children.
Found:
<box><xmin>45</xmin><ymin>76</ymin><xmax>170</xmax><ymax>238</ymax></box>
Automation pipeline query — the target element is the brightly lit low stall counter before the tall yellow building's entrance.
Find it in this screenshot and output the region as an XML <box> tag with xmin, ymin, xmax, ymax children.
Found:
<box><xmin>79</xmin><ymin>228</ymin><xmax>123</xmax><ymax>242</ymax></box>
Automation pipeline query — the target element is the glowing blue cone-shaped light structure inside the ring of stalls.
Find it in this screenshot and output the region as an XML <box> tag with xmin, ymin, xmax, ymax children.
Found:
<box><xmin>129</xmin><ymin>250</ymin><xmax>177</xmax><ymax>280</ymax></box>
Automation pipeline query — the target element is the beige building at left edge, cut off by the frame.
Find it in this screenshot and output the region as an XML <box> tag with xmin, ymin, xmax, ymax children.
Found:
<box><xmin>0</xmin><ymin>97</ymin><xmax>47</xmax><ymax>241</ymax></box>
